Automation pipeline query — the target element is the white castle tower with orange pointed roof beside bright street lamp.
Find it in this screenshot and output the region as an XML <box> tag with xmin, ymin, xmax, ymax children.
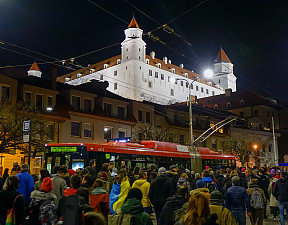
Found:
<box><xmin>211</xmin><ymin>48</ymin><xmax>237</xmax><ymax>92</ymax></box>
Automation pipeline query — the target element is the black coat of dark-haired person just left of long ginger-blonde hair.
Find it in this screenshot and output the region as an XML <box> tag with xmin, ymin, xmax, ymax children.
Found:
<box><xmin>159</xmin><ymin>194</ymin><xmax>187</xmax><ymax>225</ymax></box>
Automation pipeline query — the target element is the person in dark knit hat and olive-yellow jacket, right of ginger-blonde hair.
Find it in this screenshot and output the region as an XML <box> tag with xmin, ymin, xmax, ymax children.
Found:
<box><xmin>209</xmin><ymin>190</ymin><xmax>236</xmax><ymax>225</ymax></box>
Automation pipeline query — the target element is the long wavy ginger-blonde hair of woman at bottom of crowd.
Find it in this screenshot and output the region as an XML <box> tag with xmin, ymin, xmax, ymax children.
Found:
<box><xmin>183</xmin><ymin>191</ymin><xmax>210</xmax><ymax>225</ymax></box>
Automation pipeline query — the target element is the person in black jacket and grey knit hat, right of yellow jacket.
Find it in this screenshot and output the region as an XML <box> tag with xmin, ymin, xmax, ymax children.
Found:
<box><xmin>148</xmin><ymin>167</ymin><xmax>174</xmax><ymax>220</ymax></box>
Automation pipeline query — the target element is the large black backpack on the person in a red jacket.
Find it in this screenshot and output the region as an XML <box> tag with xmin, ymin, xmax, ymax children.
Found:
<box><xmin>58</xmin><ymin>195</ymin><xmax>83</xmax><ymax>225</ymax></box>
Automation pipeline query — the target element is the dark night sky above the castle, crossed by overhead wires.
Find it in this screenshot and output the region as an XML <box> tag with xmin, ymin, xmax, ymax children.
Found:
<box><xmin>0</xmin><ymin>0</ymin><xmax>288</xmax><ymax>104</ymax></box>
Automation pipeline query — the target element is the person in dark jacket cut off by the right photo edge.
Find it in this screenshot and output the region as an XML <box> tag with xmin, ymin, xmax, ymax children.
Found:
<box><xmin>273</xmin><ymin>172</ymin><xmax>288</xmax><ymax>225</ymax></box>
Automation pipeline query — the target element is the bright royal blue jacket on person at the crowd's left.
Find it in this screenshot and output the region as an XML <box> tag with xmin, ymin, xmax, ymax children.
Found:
<box><xmin>16</xmin><ymin>171</ymin><xmax>34</xmax><ymax>203</ymax></box>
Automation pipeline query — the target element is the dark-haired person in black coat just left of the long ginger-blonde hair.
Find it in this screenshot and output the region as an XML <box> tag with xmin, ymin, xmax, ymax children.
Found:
<box><xmin>159</xmin><ymin>186</ymin><xmax>190</xmax><ymax>225</ymax></box>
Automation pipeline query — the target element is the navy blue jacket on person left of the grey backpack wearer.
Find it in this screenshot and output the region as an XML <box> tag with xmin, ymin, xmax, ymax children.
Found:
<box><xmin>225</xmin><ymin>184</ymin><xmax>251</xmax><ymax>212</ymax></box>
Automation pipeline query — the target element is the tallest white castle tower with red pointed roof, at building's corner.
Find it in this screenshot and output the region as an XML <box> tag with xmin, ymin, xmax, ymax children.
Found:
<box><xmin>121</xmin><ymin>17</ymin><xmax>146</xmax><ymax>62</ymax></box>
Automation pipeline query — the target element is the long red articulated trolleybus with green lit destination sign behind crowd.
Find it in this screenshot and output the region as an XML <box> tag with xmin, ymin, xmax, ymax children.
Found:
<box><xmin>45</xmin><ymin>141</ymin><xmax>236</xmax><ymax>172</ymax></box>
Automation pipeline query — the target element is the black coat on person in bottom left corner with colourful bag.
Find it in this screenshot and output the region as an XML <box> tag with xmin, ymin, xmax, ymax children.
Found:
<box><xmin>0</xmin><ymin>190</ymin><xmax>25</xmax><ymax>224</ymax></box>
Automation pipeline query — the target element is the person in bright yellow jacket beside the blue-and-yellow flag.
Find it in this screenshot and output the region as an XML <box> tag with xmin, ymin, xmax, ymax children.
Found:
<box><xmin>132</xmin><ymin>172</ymin><xmax>152</xmax><ymax>214</ymax></box>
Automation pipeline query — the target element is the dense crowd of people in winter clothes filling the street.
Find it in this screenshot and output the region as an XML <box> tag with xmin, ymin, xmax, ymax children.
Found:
<box><xmin>0</xmin><ymin>161</ymin><xmax>288</xmax><ymax>225</ymax></box>
